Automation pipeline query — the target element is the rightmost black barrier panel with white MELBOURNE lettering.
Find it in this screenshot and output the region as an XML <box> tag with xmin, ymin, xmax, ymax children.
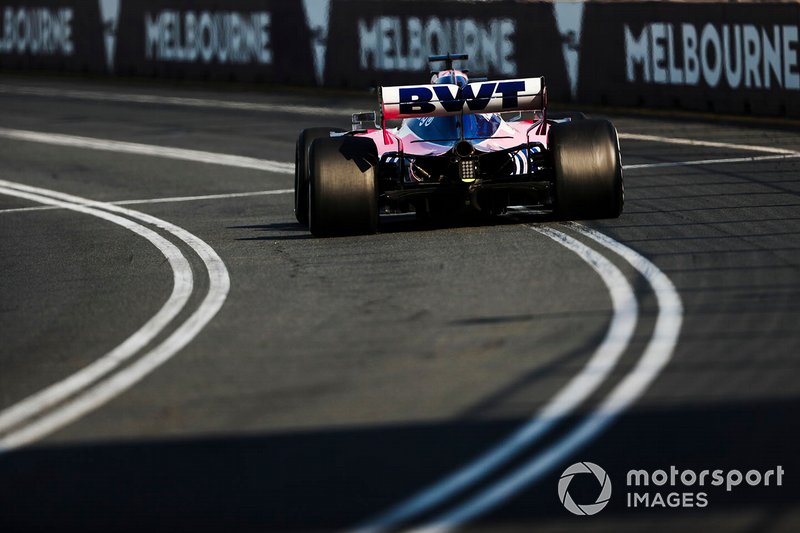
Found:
<box><xmin>577</xmin><ymin>2</ymin><xmax>800</xmax><ymax>117</ymax></box>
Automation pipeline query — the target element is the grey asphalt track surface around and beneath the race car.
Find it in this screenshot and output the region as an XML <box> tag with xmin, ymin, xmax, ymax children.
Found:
<box><xmin>0</xmin><ymin>78</ymin><xmax>800</xmax><ymax>532</ymax></box>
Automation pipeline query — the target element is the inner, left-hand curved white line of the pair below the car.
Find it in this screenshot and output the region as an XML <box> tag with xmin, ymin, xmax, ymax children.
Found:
<box><xmin>356</xmin><ymin>226</ymin><xmax>638</xmax><ymax>532</ymax></box>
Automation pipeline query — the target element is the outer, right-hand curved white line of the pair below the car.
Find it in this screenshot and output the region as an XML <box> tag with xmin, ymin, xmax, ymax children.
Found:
<box><xmin>413</xmin><ymin>223</ymin><xmax>683</xmax><ymax>533</ymax></box>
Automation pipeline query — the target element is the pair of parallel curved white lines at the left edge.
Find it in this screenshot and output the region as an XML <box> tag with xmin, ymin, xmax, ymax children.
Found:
<box><xmin>0</xmin><ymin>180</ymin><xmax>230</xmax><ymax>453</ymax></box>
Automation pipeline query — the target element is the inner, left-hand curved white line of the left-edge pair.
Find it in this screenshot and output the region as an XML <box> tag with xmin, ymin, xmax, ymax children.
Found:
<box><xmin>0</xmin><ymin>185</ymin><xmax>194</xmax><ymax>438</ymax></box>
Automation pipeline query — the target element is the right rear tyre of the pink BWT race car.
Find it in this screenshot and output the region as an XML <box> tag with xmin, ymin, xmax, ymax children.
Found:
<box><xmin>549</xmin><ymin>120</ymin><xmax>625</xmax><ymax>220</ymax></box>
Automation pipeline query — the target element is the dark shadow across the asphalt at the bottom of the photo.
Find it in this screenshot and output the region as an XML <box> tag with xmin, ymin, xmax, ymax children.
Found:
<box><xmin>0</xmin><ymin>398</ymin><xmax>800</xmax><ymax>533</ymax></box>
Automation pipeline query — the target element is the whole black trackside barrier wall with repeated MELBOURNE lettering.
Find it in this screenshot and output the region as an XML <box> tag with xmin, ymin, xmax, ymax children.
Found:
<box><xmin>0</xmin><ymin>0</ymin><xmax>800</xmax><ymax>117</ymax></box>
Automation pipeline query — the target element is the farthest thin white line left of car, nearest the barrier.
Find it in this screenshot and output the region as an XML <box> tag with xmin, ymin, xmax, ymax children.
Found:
<box><xmin>0</xmin><ymin>85</ymin><xmax>363</xmax><ymax>118</ymax></box>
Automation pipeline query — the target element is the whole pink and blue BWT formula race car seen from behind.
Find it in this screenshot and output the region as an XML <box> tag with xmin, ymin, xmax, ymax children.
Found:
<box><xmin>295</xmin><ymin>54</ymin><xmax>624</xmax><ymax>236</ymax></box>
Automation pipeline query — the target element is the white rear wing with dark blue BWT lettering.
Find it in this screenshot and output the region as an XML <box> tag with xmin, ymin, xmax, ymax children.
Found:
<box><xmin>378</xmin><ymin>77</ymin><xmax>547</xmax><ymax>122</ymax></box>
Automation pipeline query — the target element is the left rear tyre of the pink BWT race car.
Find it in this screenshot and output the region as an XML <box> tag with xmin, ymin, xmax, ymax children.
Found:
<box><xmin>308</xmin><ymin>137</ymin><xmax>378</xmax><ymax>237</ymax></box>
